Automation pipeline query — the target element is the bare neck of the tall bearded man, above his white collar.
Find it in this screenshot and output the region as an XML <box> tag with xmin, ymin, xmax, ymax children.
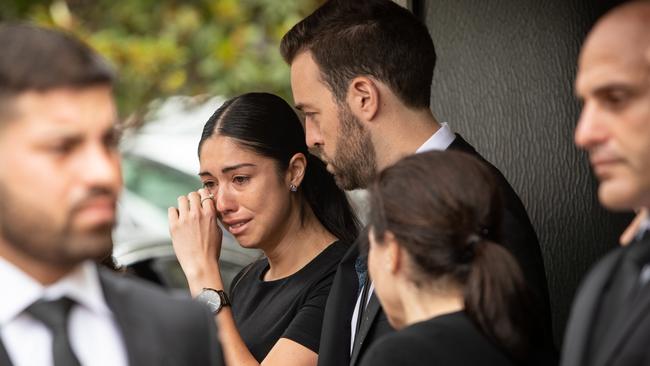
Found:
<box><xmin>373</xmin><ymin>107</ymin><xmax>440</xmax><ymax>170</ymax></box>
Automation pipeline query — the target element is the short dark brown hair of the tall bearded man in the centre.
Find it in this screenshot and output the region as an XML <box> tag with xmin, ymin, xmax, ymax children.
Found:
<box><xmin>280</xmin><ymin>0</ymin><xmax>436</xmax><ymax>108</ymax></box>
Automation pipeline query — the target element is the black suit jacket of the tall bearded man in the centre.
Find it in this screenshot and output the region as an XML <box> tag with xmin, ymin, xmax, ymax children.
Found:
<box><xmin>318</xmin><ymin>134</ymin><xmax>554</xmax><ymax>366</ymax></box>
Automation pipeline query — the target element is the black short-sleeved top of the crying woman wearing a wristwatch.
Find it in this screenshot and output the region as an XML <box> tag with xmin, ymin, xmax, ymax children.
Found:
<box><xmin>230</xmin><ymin>241</ymin><xmax>348</xmax><ymax>362</ymax></box>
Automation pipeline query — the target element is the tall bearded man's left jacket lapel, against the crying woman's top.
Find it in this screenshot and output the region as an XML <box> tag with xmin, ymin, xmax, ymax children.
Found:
<box><xmin>318</xmin><ymin>242</ymin><xmax>363</xmax><ymax>366</ymax></box>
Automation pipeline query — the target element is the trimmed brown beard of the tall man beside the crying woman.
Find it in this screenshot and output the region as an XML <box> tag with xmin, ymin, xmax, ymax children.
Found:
<box><xmin>329</xmin><ymin>103</ymin><xmax>377</xmax><ymax>191</ymax></box>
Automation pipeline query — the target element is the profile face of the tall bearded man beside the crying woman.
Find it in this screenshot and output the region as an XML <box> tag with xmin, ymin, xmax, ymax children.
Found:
<box><xmin>291</xmin><ymin>52</ymin><xmax>377</xmax><ymax>190</ymax></box>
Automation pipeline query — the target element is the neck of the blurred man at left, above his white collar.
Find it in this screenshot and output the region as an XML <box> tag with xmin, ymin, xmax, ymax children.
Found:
<box><xmin>0</xmin><ymin>239</ymin><xmax>77</xmax><ymax>286</ymax></box>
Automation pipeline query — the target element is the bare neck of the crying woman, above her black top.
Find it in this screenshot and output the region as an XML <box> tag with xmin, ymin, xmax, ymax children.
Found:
<box><xmin>264</xmin><ymin>207</ymin><xmax>336</xmax><ymax>281</ymax></box>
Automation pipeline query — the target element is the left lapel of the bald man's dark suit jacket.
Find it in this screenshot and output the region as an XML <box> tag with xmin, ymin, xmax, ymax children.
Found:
<box><xmin>561</xmin><ymin>250</ymin><xmax>622</xmax><ymax>366</ymax></box>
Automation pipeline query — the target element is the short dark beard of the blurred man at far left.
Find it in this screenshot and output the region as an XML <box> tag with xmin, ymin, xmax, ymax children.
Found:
<box><xmin>0</xmin><ymin>183</ymin><xmax>114</xmax><ymax>268</ymax></box>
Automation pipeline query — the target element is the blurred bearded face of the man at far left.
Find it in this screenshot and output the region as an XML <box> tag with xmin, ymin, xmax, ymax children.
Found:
<box><xmin>0</xmin><ymin>86</ymin><xmax>121</xmax><ymax>274</ymax></box>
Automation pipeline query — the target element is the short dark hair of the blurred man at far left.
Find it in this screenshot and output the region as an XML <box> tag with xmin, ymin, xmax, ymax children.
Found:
<box><xmin>0</xmin><ymin>23</ymin><xmax>115</xmax><ymax>119</ymax></box>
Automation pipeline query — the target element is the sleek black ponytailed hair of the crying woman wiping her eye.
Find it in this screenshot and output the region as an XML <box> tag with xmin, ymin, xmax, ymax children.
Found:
<box><xmin>198</xmin><ymin>93</ymin><xmax>360</xmax><ymax>243</ymax></box>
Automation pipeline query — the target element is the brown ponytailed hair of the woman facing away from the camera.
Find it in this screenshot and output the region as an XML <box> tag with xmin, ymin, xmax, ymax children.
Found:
<box><xmin>369</xmin><ymin>151</ymin><xmax>536</xmax><ymax>360</ymax></box>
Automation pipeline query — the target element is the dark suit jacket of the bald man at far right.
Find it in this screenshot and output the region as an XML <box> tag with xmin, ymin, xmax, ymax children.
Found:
<box><xmin>561</xmin><ymin>241</ymin><xmax>650</xmax><ymax>366</ymax></box>
